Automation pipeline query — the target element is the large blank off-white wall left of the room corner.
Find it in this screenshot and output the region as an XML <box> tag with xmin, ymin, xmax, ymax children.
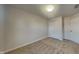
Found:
<box><xmin>5</xmin><ymin>7</ymin><xmax>48</xmax><ymax>50</ymax></box>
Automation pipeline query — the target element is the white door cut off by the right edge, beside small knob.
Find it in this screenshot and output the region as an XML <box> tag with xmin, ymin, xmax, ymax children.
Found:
<box><xmin>70</xmin><ymin>14</ymin><xmax>79</xmax><ymax>43</ymax></box>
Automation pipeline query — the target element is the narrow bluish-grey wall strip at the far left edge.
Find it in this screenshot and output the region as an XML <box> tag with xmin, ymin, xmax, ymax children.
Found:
<box><xmin>0</xmin><ymin>5</ymin><xmax>5</xmax><ymax>53</ymax></box>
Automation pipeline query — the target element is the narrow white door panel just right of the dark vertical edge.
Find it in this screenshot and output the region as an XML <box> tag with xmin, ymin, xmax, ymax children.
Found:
<box><xmin>64</xmin><ymin>17</ymin><xmax>71</xmax><ymax>40</ymax></box>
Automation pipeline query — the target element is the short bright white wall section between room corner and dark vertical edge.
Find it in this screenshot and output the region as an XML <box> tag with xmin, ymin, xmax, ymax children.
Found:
<box><xmin>48</xmin><ymin>16</ymin><xmax>63</xmax><ymax>40</ymax></box>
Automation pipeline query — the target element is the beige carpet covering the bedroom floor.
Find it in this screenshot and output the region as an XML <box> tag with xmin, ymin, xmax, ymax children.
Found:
<box><xmin>7</xmin><ymin>38</ymin><xmax>79</xmax><ymax>54</ymax></box>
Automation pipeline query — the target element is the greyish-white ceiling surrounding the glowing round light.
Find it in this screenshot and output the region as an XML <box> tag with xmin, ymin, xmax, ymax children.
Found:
<box><xmin>10</xmin><ymin>4</ymin><xmax>79</xmax><ymax>18</ymax></box>
